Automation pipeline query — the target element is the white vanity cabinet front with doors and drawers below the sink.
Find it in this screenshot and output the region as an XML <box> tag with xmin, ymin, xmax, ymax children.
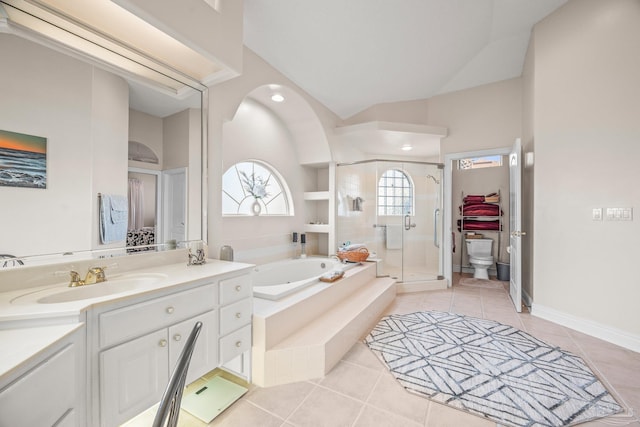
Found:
<box><xmin>91</xmin><ymin>270</ymin><xmax>252</xmax><ymax>426</ymax></box>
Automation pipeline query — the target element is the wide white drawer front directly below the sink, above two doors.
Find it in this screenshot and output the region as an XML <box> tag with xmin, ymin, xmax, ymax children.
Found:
<box><xmin>100</xmin><ymin>285</ymin><xmax>216</xmax><ymax>348</ymax></box>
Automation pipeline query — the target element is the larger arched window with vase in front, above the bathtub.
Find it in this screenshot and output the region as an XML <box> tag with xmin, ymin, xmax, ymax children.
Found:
<box><xmin>222</xmin><ymin>160</ymin><xmax>293</xmax><ymax>215</ymax></box>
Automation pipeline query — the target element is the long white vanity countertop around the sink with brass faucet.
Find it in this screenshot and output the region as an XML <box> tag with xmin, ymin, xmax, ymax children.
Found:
<box><xmin>0</xmin><ymin>260</ymin><xmax>253</xmax><ymax>378</ymax></box>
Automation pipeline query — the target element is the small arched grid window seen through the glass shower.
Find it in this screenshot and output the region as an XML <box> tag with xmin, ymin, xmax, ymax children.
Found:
<box><xmin>378</xmin><ymin>169</ymin><xmax>414</xmax><ymax>215</ymax></box>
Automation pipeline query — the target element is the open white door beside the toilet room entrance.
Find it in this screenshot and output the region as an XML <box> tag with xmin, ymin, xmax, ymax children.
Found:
<box><xmin>509</xmin><ymin>138</ymin><xmax>526</xmax><ymax>313</ymax></box>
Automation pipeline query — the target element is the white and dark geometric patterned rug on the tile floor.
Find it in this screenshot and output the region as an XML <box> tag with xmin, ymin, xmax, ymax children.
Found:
<box><xmin>365</xmin><ymin>311</ymin><xmax>622</xmax><ymax>426</ymax></box>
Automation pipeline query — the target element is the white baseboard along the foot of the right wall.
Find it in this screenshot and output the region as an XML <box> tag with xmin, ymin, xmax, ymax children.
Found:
<box><xmin>531</xmin><ymin>303</ymin><xmax>640</xmax><ymax>352</ymax></box>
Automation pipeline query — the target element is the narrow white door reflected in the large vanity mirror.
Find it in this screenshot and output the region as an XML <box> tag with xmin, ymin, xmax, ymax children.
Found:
<box><xmin>162</xmin><ymin>168</ymin><xmax>187</xmax><ymax>242</ymax></box>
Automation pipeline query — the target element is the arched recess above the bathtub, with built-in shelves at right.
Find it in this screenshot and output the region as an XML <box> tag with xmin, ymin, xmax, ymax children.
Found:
<box><xmin>211</xmin><ymin>85</ymin><xmax>333</xmax><ymax>264</ymax></box>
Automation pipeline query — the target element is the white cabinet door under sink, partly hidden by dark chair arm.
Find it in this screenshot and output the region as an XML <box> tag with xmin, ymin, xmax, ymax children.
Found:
<box><xmin>169</xmin><ymin>310</ymin><xmax>218</xmax><ymax>384</ymax></box>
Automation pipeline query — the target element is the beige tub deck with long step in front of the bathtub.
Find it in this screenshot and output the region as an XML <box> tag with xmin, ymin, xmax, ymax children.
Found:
<box><xmin>252</xmin><ymin>263</ymin><xmax>396</xmax><ymax>387</ymax></box>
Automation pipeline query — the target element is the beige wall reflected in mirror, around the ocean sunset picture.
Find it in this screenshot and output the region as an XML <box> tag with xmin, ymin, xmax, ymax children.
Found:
<box><xmin>0</xmin><ymin>34</ymin><xmax>129</xmax><ymax>256</ymax></box>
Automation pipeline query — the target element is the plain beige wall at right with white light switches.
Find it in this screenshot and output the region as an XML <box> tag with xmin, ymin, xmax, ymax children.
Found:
<box><xmin>529</xmin><ymin>0</ymin><xmax>640</xmax><ymax>342</ymax></box>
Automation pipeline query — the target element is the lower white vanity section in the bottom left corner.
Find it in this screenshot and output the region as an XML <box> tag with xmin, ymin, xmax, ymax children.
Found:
<box><xmin>0</xmin><ymin>327</ymin><xmax>86</xmax><ymax>427</ymax></box>
